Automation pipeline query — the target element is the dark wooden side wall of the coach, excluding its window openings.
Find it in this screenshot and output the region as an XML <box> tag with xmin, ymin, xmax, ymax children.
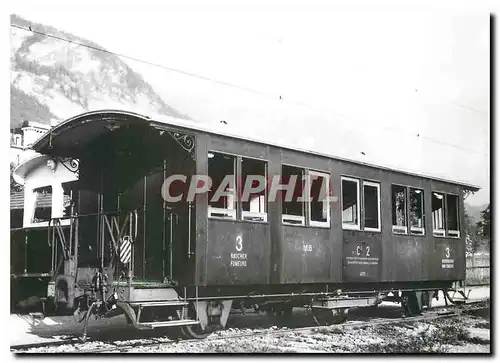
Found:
<box><xmin>196</xmin><ymin>133</ymin><xmax>467</xmax><ymax>286</ymax></box>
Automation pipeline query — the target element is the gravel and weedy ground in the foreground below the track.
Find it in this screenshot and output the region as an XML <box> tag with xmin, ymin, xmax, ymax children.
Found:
<box><xmin>14</xmin><ymin>315</ymin><xmax>490</xmax><ymax>354</ymax></box>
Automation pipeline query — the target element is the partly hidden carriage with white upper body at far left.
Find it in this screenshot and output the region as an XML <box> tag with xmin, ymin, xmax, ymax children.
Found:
<box><xmin>10</xmin><ymin>155</ymin><xmax>76</xmax><ymax>311</ymax></box>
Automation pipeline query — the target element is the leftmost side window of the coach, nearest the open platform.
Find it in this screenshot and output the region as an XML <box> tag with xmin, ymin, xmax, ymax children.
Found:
<box><xmin>208</xmin><ymin>152</ymin><xmax>236</xmax><ymax>219</ymax></box>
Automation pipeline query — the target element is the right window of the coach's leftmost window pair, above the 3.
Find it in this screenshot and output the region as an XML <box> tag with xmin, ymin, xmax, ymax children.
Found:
<box><xmin>241</xmin><ymin>158</ymin><xmax>267</xmax><ymax>222</ymax></box>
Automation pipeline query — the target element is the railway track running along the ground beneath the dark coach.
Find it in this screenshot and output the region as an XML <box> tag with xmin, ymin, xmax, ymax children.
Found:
<box><xmin>11</xmin><ymin>304</ymin><xmax>485</xmax><ymax>354</ymax></box>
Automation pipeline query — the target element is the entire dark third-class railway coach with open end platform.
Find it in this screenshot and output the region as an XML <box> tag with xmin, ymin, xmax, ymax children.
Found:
<box><xmin>26</xmin><ymin>111</ymin><xmax>477</xmax><ymax>337</ymax></box>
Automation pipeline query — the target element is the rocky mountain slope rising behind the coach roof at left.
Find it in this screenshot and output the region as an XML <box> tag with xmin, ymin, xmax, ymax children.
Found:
<box><xmin>10</xmin><ymin>15</ymin><xmax>189</xmax><ymax>128</ymax></box>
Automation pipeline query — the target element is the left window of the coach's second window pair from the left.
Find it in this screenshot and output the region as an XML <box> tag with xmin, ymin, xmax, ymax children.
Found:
<box><xmin>281</xmin><ymin>165</ymin><xmax>305</xmax><ymax>225</ymax></box>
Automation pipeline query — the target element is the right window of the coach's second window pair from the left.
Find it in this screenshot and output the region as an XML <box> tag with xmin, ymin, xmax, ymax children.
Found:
<box><xmin>309</xmin><ymin>170</ymin><xmax>330</xmax><ymax>227</ymax></box>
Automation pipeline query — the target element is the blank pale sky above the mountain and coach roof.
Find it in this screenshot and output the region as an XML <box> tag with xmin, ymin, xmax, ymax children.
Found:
<box><xmin>12</xmin><ymin>7</ymin><xmax>490</xmax><ymax>205</ymax></box>
